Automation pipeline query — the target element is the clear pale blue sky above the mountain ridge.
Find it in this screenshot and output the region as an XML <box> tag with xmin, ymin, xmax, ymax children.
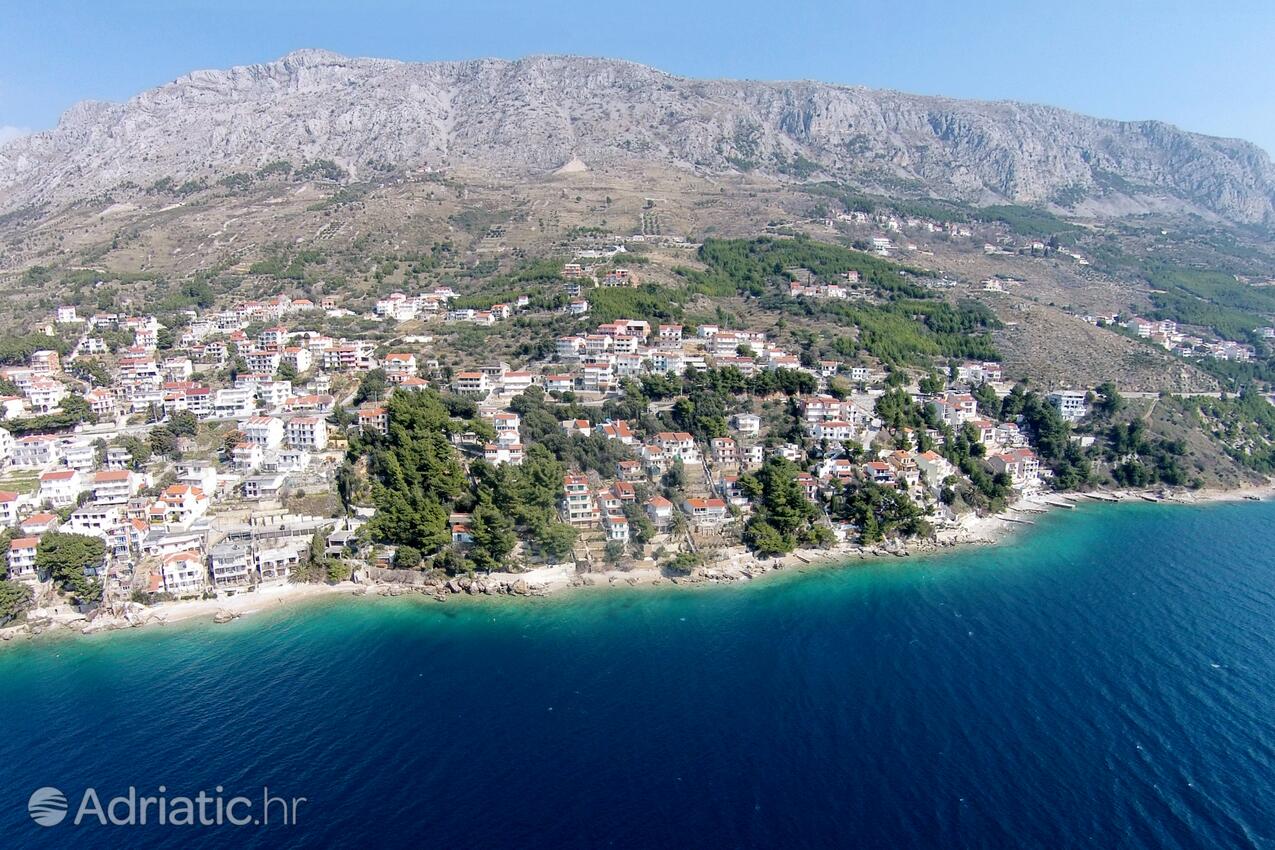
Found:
<box><xmin>0</xmin><ymin>0</ymin><xmax>1275</xmax><ymax>152</ymax></box>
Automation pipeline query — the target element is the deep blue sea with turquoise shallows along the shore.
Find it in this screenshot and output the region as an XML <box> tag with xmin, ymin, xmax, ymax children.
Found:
<box><xmin>0</xmin><ymin>503</ymin><xmax>1275</xmax><ymax>850</ymax></box>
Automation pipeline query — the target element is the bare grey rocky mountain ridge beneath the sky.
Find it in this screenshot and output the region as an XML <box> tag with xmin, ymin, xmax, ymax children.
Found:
<box><xmin>0</xmin><ymin>50</ymin><xmax>1275</xmax><ymax>226</ymax></box>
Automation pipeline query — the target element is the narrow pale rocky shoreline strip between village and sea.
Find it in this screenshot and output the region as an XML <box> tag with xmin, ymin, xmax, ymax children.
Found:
<box><xmin>0</xmin><ymin>482</ymin><xmax>1275</xmax><ymax>645</ymax></box>
